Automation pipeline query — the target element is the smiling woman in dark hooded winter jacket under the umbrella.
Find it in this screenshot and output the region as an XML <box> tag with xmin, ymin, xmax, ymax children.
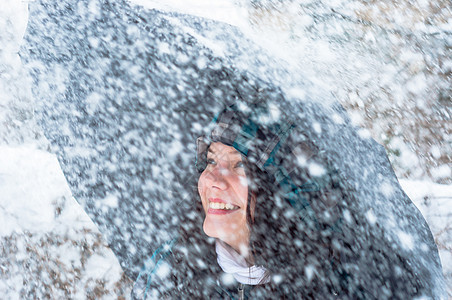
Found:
<box><xmin>133</xmin><ymin>102</ymin><xmax>430</xmax><ymax>299</ymax></box>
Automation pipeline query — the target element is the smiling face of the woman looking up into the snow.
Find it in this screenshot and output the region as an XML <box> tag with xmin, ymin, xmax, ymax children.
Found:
<box><xmin>198</xmin><ymin>143</ymin><xmax>249</xmax><ymax>255</ymax></box>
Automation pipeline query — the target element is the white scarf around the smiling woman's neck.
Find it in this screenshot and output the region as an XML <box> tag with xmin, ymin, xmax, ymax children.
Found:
<box><xmin>215</xmin><ymin>240</ymin><xmax>270</xmax><ymax>285</ymax></box>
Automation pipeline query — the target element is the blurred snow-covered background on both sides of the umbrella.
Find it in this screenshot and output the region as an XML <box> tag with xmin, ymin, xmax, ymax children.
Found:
<box><xmin>0</xmin><ymin>0</ymin><xmax>452</xmax><ymax>299</ymax></box>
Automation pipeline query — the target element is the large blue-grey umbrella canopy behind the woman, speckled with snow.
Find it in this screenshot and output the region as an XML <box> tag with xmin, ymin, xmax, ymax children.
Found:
<box><xmin>22</xmin><ymin>0</ymin><xmax>442</xmax><ymax>294</ymax></box>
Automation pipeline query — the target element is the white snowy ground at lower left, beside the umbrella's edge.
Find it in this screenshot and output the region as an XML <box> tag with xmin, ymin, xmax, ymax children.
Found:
<box><xmin>0</xmin><ymin>145</ymin><xmax>130</xmax><ymax>299</ymax></box>
